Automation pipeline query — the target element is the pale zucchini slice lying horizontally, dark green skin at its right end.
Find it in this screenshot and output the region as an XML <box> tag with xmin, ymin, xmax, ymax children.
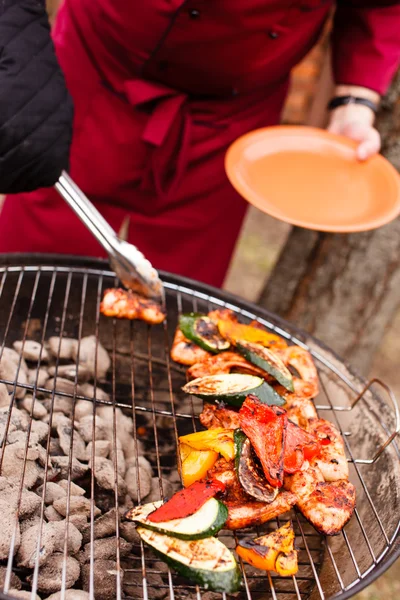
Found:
<box><xmin>182</xmin><ymin>373</ymin><xmax>285</xmax><ymax>406</ymax></box>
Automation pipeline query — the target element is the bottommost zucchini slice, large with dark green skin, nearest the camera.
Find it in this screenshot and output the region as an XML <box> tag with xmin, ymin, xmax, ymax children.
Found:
<box><xmin>137</xmin><ymin>527</ymin><xmax>242</xmax><ymax>594</ymax></box>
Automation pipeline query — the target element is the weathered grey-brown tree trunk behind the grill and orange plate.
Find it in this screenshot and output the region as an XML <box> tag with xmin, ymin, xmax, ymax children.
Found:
<box><xmin>259</xmin><ymin>72</ymin><xmax>400</xmax><ymax>373</ymax></box>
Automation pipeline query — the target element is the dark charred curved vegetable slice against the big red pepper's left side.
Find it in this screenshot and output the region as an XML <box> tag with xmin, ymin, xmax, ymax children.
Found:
<box><xmin>234</xmin><ymin>429</ymin><xmax>279</xmax><ymax>503</ymax></box>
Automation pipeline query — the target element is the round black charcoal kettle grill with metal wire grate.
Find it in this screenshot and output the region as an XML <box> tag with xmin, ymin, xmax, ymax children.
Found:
<box><xmin>0</xmin><ymin>255</ymin><xmax>400</xmax><ymax>600</ymax></box>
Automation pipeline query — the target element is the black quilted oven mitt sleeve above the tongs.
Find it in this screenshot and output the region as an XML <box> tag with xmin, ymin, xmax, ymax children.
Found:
<box><xmin>0</xmin><ymin>0</ymin><xmax>73</xmax><ymax>194</ymax></box>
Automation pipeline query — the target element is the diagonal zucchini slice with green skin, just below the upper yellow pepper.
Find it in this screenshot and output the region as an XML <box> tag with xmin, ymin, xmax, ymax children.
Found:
<box><xmin>236</xmin><ymin>341</ymin><xmax>294</xmax><ymax>392</ymax></box>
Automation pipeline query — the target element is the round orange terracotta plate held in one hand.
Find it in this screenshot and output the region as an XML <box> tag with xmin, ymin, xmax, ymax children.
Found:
<box><xmin>225</xmin><ymin>126</ymin><xmax>400</xmax><ymax>232</ymax></box>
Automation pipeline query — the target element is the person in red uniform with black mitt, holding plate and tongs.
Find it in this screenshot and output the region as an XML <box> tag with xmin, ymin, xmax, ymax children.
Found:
<box><xmin>0</xmin><ymin>0</ymin><xmax>400</xmax><ymax>286</ymax></box>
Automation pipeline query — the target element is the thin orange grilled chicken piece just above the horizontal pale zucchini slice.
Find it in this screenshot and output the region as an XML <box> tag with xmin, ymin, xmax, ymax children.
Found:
<box><xmin>187</xmin><ymin>351</ymin><xmax>271</xmax><ymax>381</ymax></box>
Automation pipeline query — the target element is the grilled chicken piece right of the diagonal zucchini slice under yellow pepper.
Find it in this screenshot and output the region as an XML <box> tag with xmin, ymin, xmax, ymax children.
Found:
<box><xmin>275</xmin><ymin>346</ymin><xmax>319</xmax><ymax>398</ymax></box>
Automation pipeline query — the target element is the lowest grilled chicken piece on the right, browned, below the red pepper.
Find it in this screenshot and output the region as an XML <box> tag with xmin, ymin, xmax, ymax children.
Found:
<box><xmin>284</xmin><ymin>467</ymin><xmax>356</xmax><ymax>535</ymax></box>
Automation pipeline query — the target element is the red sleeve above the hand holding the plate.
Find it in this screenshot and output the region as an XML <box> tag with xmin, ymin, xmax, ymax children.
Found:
<box><xmin>332</xmin><ymin>0</ymin><xmax>400</xmax><ymax>94</ymax></box>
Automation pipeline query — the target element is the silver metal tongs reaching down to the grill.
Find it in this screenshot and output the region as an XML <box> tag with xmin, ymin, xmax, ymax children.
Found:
<box><xmin>55</xmin><ymin>171</ymin><xmax>164</xmax><ymax>301</ymax></box>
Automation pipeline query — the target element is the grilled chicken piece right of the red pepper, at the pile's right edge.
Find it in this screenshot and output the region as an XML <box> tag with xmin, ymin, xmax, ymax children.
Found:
<box><xmin>309</xmin><ymin>419</ymin><xmax>349</xmax><ymax>481</ymax></box>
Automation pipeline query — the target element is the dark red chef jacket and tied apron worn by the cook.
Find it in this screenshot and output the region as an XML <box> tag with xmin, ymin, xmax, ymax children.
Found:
<box><xmin>0</xmin><ymin>0</ymin><xmax>400</xmax><ymax>286</ymax></box>
